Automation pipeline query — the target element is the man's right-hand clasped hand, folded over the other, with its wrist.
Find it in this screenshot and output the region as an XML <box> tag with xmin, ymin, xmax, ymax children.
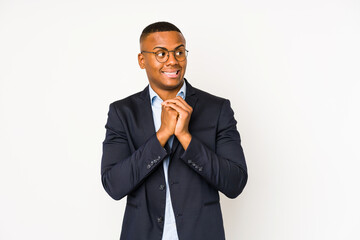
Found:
<box><xmin>162</xmin><ymin>96</ymin><xmax>193</xmax><ymax>150</ymax></box>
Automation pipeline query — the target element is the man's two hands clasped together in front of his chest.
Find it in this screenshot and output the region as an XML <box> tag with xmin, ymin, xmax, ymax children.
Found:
<box><xmin>157</xmin><ymin>96</ymin><xmax>193</xmax><ymax>150</ymax></box>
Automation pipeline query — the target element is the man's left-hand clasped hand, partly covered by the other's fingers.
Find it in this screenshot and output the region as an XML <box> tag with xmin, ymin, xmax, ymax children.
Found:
<box><xmin>156</xmin><ymin>105</ymin><xmax>179</xmax><ymax>147</ymax></box>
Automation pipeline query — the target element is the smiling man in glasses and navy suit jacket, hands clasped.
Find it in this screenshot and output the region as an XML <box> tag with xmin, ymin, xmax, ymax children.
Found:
<box><xmin>101</xmin><ymin>22</ymin><xmax>247</xmax><ymax>240</ymax></box>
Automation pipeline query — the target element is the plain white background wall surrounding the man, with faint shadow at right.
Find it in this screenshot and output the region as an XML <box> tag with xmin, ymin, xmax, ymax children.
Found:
<box><xmin>0</xmin><ymin>0</ymin><xmax>360</xmax><ymax>240</ymax></box>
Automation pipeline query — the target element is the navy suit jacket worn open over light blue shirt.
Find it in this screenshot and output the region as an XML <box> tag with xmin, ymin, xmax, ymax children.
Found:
<box><xmin>101</xmin><ymin>80</ymin><xmax>247</xmax><ymax>240</ymax></box>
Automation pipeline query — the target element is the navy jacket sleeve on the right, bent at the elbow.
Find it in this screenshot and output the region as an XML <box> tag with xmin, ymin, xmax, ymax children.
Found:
<box><xmin>180</xmin><ymin>100</ymin><xmax>248</xmax><ymax>198</ymax></box>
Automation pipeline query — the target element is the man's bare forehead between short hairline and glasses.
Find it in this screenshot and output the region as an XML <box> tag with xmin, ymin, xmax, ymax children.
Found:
<box><xmin>140</xmin><ymin>31</ymin><xmax>185</xmax><ymax>48</ymax></box>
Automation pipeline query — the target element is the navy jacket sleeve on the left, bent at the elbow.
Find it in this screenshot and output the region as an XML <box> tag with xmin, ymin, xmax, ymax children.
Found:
<box><xmin>101</xmin><ymin>103</ymin><xmax>167</xmax><ymax>200</ymax></box>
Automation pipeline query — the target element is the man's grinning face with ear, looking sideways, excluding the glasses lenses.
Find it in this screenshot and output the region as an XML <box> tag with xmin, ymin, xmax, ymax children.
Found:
<box><xmin>138</xmin><ymin>31</ymin><xmax>187</xmax><ymax>94</ymax></box>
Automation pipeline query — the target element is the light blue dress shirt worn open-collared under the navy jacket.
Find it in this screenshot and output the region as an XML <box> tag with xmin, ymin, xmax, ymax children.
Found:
<box><xmin>149</xmin><ymin>82</ymin><xmax>186</xmax><ymax>240</ymax></box>
